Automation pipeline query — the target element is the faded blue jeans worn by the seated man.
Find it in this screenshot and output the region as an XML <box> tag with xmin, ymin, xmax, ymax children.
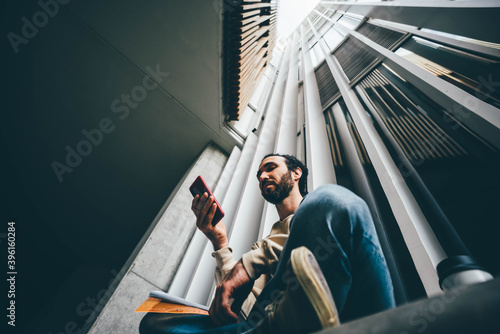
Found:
<box><xmin>141</xmin><ymin>185</ymin><xmax>395</xmax><ymax>334</ymax></box>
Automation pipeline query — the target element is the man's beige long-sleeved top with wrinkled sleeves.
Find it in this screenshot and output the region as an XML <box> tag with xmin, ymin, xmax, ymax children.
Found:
<box><xmin>212</xmin><ymin>215</ymin><xmax>293</xmax><ymax>319</ymax></box>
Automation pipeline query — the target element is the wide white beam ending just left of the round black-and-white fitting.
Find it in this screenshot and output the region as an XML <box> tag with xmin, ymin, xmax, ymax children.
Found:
<box><xmin>309</xmin><ymin>17</ymin><xmax>446</xmax><ymax>295</ymax></box>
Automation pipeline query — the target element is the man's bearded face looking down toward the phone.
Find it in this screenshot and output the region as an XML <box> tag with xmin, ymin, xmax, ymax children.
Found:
<box><xmin>257</xmin><ymin>156</ymin><xmax>294</xmax><ymax>204</ymax></box>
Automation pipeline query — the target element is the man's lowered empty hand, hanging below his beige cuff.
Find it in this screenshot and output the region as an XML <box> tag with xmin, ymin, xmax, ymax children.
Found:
<box><xmin>208</xmin><ymin>260</ymin><xmax>253</xmax><ymax>326</ymax></box>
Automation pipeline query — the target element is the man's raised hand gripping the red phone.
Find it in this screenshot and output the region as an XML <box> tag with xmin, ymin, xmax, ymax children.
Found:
<box><xmin>191</xmin><ymin>193</ymin><xmax>229</xmax><ymax>250</ymax></box>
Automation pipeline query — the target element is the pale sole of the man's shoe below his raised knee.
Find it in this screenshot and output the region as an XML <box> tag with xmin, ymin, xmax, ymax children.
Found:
<box><xmin>290</xmin><ymin>247</ymin><xmax>340</xmax><ymax>328</ymax></box>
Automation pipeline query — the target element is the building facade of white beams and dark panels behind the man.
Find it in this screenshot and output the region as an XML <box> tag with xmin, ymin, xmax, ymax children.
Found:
<box><xmin>90</xmin><ymin>1</ymin><xmax>500</xmax><ymax>332</ymax></box>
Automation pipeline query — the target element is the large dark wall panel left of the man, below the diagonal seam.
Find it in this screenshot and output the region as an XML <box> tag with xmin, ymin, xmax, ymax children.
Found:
<box><xmin>0</xmin><ymin>0</ymin><xmax>229</xmax><ymax>333</ymax></box>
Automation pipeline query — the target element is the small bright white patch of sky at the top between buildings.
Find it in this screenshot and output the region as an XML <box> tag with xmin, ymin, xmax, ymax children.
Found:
<box><xmin>278</xmin><ymin>0</ymin><xmax>320</xmax><ymax>38</ymax></box>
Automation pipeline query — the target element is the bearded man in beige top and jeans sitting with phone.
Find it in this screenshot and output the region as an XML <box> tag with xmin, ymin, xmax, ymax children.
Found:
<box><xmin>141</xmin><ymin>154</ymin><xmax>395</xmax><ymax>333</ymax></box>
